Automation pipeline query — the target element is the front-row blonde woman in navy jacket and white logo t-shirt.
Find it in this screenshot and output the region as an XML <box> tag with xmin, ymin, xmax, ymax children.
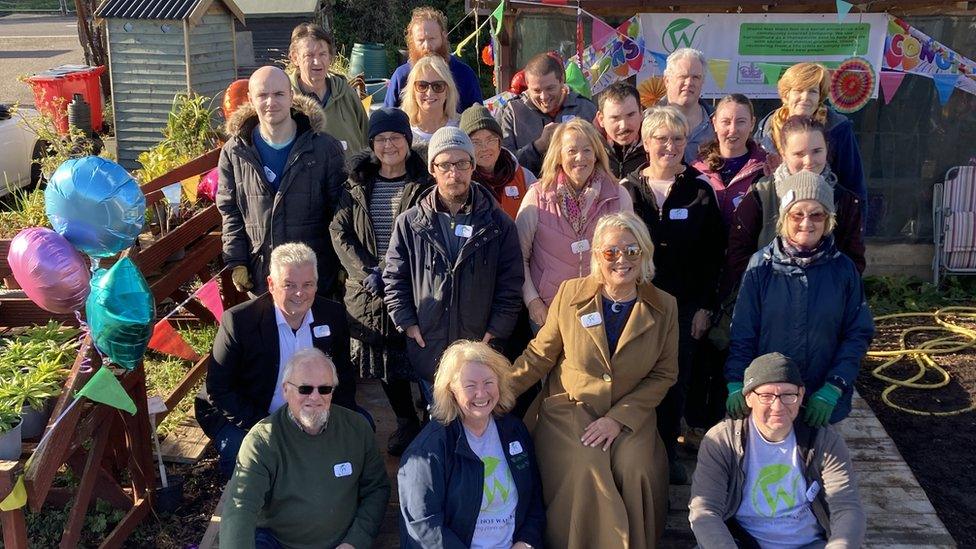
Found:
<box><xmin>397</xmin><ymin>340</ymin><xmax>545</xmax><ymax>549</ymax></box>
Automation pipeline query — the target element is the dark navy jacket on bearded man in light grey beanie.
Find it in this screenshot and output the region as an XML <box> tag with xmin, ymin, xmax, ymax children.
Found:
<box><xmin>383</xmin><ymin>183</ymin><xmax>525</xmax><ymax>381</ymax></box>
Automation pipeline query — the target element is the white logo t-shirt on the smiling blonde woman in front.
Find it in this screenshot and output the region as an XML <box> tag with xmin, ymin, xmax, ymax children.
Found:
<box><xmin>464</xmin><ymin>419</ymin><xmax>518</xmax><ymax>549</ymax></box>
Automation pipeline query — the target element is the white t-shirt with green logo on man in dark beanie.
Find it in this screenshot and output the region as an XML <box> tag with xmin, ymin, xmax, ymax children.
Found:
<box><xmin>735</xmin><ymin>416</ymin><xmax>824</xmax><ymax>549</ymax></box>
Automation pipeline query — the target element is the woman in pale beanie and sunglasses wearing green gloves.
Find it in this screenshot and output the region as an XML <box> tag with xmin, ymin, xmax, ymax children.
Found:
<box><xmin>725</xmin><ymin>171</ymin><xmax>874</xmax><ymax>427</ymax></box>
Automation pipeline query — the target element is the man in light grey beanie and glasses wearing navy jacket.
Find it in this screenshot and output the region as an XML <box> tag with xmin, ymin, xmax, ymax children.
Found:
<box><xmin>383</xmin><ymin>127</ymin><xmax>524</xmax><ymax>402</ymax></box>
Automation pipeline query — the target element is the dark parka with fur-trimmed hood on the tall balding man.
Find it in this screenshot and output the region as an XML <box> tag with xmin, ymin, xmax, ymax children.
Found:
<box><xmin>216</xmin><ymin>94</ymin><xmax>346</xmax><ymax>296</ymax></box>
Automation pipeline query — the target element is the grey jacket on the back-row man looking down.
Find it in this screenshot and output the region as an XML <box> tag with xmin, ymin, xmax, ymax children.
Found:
<box><xmin>498</xmin><ymin>91</ymin><xmax>596</xmax><ymax>176</ymax></box>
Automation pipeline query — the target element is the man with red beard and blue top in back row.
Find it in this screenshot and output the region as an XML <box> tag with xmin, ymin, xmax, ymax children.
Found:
<box><xmin>383</xmin><ymin>6</ymin><xmax>484</xmax><ymax>113</ymax></box>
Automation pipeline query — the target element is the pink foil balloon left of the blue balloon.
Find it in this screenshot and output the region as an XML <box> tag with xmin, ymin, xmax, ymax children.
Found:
<box><xmin>7</xmin><ymin>227</ymin><xmax>91</xmax><ymax>313</ymax></box>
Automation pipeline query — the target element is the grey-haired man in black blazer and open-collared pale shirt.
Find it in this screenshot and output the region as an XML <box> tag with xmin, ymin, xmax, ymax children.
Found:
<box><xmin>195</xmin><ymin>243</ymin><xmax>358</xmax><ymax>477</ymax></box>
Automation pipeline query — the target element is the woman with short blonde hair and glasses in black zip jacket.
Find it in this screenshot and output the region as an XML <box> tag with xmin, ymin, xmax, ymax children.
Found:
<box><xmin>621</xmin><ymin>107</ymin><xmax>726</xmax><ymax>484</ymax></box>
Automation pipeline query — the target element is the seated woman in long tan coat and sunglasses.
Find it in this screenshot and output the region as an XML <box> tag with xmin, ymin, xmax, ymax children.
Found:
<box><xmin>513</xmin><ymin>212</ymin><xmax>678</xmax><ymax>549</ymax></box>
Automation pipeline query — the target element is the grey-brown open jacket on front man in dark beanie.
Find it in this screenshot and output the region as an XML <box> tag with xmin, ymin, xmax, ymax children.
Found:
<box><xmin>688</xmin><ymin>418</ymin><xmax>865</xmax><ymax>549</ymax></box>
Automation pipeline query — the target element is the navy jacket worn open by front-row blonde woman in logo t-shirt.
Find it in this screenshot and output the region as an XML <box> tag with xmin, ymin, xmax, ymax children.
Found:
<box><xmin>397</xmin><ymin>415</ymin><xmax>546</xmax><ymax>549</ymax></box>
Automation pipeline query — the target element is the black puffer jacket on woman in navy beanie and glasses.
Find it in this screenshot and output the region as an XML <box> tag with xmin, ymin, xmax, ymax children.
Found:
<box><xmin>329</xmin><ymin>149</ymin><xmax>432</xmax><ymax>348</ymax></box>
